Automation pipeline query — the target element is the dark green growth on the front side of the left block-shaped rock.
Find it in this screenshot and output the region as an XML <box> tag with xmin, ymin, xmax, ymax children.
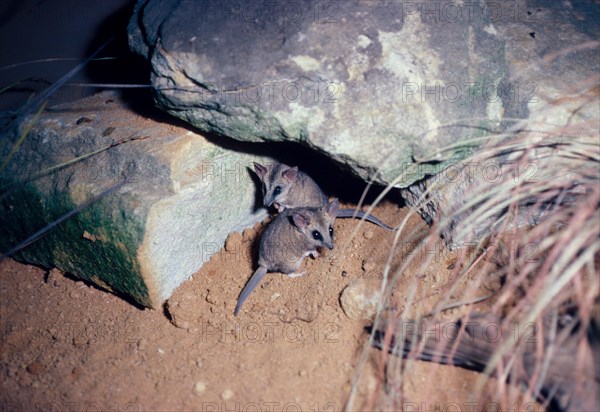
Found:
<box><xmin>0</xmin><ymin>182</ymin><xmax>152</xmax><ymax>306</ymax></box>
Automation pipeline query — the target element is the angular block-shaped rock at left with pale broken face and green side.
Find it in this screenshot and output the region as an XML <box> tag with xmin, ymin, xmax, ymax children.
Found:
<box><xmin>0</xmin><ymin>93</ymin><xmax>269</xmax><ymax>307</ymax></box>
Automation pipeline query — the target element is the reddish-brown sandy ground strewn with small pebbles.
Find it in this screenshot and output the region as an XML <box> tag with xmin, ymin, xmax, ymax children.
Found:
<box><xmin>0</xmin><ymin>202</ymin><xmax>536</xmax><ymax>411</ymax></box>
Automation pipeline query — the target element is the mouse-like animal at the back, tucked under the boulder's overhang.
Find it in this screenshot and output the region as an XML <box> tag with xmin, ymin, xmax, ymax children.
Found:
<box><xmin>254</xmin><ymin>162</ymin><xmax>394</xmax><ymax>230</ymax></box>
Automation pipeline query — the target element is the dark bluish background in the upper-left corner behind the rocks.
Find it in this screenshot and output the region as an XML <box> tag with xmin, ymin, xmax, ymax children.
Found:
<box><xmin>0</xmin><ymin>0</ymin><xmax>143</xmax><ymax>115</ymax></box>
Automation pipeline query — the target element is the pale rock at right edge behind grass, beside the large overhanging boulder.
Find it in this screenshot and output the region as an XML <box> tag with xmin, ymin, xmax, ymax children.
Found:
<box><xmin>401</xmin><ymin>2</ymin><xmax>600</xmax><ymax>243</ymax></box>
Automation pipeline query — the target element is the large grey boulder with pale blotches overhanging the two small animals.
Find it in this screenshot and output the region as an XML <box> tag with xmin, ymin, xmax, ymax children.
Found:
<box><xmin>129</xmin><ymin>0</ymin><xmax>510</xmax><ymax>187</ymax></box>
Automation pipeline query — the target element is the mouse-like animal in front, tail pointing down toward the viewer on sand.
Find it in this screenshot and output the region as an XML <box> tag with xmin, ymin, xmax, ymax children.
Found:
<box><xmin>233</xmin><ymin>199</ymin><xmax>340</xmax><ymax>316</ymax></box>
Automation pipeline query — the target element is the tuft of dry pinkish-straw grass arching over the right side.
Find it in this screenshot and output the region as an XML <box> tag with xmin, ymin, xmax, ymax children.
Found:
<box><xmin>347</xmin><ymin>79</ymin><xmax>600</xmax><ymax>410</ymax></box>
